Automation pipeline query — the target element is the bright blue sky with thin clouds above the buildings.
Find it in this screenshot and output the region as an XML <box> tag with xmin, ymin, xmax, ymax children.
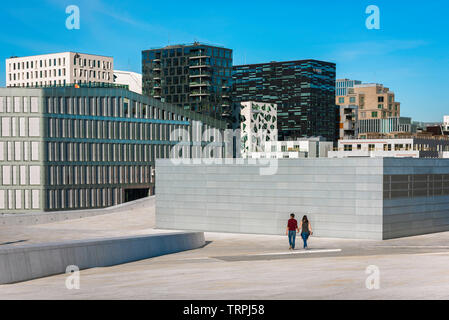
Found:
<box><xmin>0</xmin><ymin>0</ymin><xmax>449</xmax><ymax>121</ymax></box>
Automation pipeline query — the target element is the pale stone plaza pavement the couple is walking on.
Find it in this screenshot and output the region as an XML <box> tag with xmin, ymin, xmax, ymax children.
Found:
<box><xmin>0</xmin><ymin>199</ymin><xmax>449</xmax><ymax>299</ymax></box>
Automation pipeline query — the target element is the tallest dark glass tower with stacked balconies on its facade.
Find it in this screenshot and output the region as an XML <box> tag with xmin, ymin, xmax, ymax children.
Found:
<box><xmin>142</xmin><ymin>42</ymin><xmax>232</xmax><ymax>125</ymax></box>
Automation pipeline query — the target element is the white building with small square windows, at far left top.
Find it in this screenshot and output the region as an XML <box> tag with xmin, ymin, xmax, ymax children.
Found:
<box><xmin>6</xmin><ymin>52</ymin><xmax>114</xmax><ymax>87</ymax></box>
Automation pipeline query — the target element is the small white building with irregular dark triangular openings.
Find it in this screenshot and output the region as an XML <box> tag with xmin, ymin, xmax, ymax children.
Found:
<box><xmin>239</xmin><ymin>101</ymin><xmax>277</xmax><ymax>158</ymax></box>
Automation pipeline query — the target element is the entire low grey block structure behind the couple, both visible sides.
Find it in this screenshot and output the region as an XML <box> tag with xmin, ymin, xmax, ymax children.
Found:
<box><xmin>156</xmin><ymin>158</ymin><xmax>449</xmax><ymax>240</ymax></box>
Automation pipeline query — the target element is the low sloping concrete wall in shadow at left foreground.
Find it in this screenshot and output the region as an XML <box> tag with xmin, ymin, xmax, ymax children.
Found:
<box><xmin>0</xmin><ymin>232</ymin><xmax>205</xmax><ymax>284</ymax></box>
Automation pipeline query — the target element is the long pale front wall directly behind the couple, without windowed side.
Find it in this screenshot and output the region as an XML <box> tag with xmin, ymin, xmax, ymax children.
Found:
<box><xmin>156</xmin><ymin>158</ymin><xmax>383</xmax><ymax>239</ymax></box>
